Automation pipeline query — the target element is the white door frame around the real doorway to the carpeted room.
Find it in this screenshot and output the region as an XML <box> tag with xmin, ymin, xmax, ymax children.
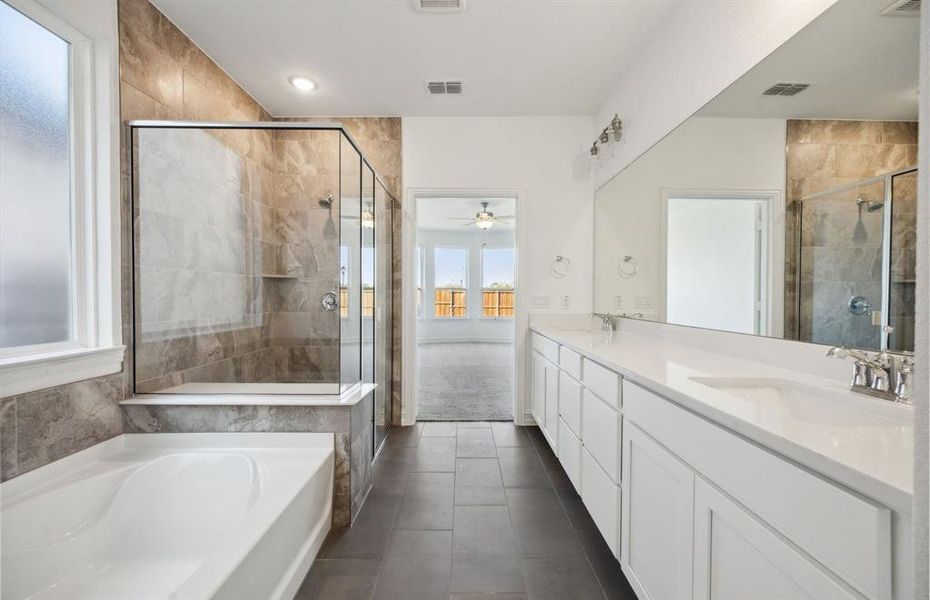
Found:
<box><xmin>400</xmin><ymin>188</ymin><xmax>532</xmax><ymax>425</ymax></box>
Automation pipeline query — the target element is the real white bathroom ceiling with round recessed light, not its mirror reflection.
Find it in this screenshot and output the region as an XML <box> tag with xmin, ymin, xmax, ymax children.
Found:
<box><xmin>153</xmin><ymin>0</ymin><xmax>675</xmax><ymax>116</ymax></box>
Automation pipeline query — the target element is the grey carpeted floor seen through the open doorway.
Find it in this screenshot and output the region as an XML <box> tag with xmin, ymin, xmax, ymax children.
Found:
<box><xmin>417</xmin><ymin>343</ymin><xmax>514</xmax><ymax>421</ymax></box>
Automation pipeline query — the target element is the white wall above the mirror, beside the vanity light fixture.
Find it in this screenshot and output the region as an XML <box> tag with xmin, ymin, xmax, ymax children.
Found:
<box><xmin>588</xmin><ymin>0</ymin><xmax>835</xmax><ymax>185</ymax></box>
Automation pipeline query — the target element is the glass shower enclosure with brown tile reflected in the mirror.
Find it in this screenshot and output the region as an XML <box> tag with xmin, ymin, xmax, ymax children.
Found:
<box><xmin>795</xmin><ymin>167</ymin><xmax>917</xmax><ymax>352</ymax></box>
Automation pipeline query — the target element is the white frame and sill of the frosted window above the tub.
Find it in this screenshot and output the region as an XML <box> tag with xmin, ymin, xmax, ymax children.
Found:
<box><xmin>0</xmin><ymin>0</ymin><xmax>125</xmax><ymax>396</ymax></box>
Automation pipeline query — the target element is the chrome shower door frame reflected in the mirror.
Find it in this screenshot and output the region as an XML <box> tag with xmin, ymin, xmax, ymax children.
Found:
<box><xmin>794</xmin><ymin>165</ymin><xmax>920</xmax><ymax>352</ymax></box>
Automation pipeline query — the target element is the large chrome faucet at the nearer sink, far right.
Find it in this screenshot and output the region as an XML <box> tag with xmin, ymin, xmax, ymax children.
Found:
<box><xmin>827</xmin><ymin>346</ymin><xmax>914</xmax><ymax>404</ymax></box>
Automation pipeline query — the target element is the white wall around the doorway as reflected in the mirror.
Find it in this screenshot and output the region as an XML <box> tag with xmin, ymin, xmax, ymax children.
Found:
<box><xmin>594</xmin><ymin>117</ymin><xmax>785</xmax><ymax>319</ymax></box>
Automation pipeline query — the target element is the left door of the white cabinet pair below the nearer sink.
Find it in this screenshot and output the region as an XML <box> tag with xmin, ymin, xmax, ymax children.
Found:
<box><xmin>620</xmin><ymin>421</ymin><xmax>692</xmax><ymax>600</ymax></box>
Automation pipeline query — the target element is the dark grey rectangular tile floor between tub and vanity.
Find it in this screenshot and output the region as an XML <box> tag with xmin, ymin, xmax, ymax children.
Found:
<box><xmin>297</xmin><ymin>422</ymin><xmax>635</xmax><ymax>600</ymax></box>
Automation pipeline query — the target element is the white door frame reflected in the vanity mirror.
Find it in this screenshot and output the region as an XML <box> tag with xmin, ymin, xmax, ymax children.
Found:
<box><xmin>658</xmin><ymin>188</ymin><xmax>785</xmax><ymax>338</ymax></box>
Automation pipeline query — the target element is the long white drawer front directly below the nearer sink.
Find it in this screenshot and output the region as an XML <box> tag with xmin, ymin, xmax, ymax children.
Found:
<box><xmin>623</xmin><ymin>381</ymin><xmax>891</xmax><ymax>598</ymax></box>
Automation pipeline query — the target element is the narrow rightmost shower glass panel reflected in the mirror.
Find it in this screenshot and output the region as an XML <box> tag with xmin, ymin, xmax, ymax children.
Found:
<box><xmin>888</xmin><ymin>171</ymin><xmax>917</xmax><ymax>352</ymax></box>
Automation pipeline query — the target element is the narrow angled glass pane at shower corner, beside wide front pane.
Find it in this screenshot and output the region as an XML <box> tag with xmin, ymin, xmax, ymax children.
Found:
<box><xmin>339</xmin><ymin>138</ymin><xmax>362</xmax><ymax>391</ymax></box>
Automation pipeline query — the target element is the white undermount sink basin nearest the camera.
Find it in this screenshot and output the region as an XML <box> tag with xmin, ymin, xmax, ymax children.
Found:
<box><xmin>690</xmin><ymin>377</ymin><xmax>907</xmax><ymax>426</ymax></box>
